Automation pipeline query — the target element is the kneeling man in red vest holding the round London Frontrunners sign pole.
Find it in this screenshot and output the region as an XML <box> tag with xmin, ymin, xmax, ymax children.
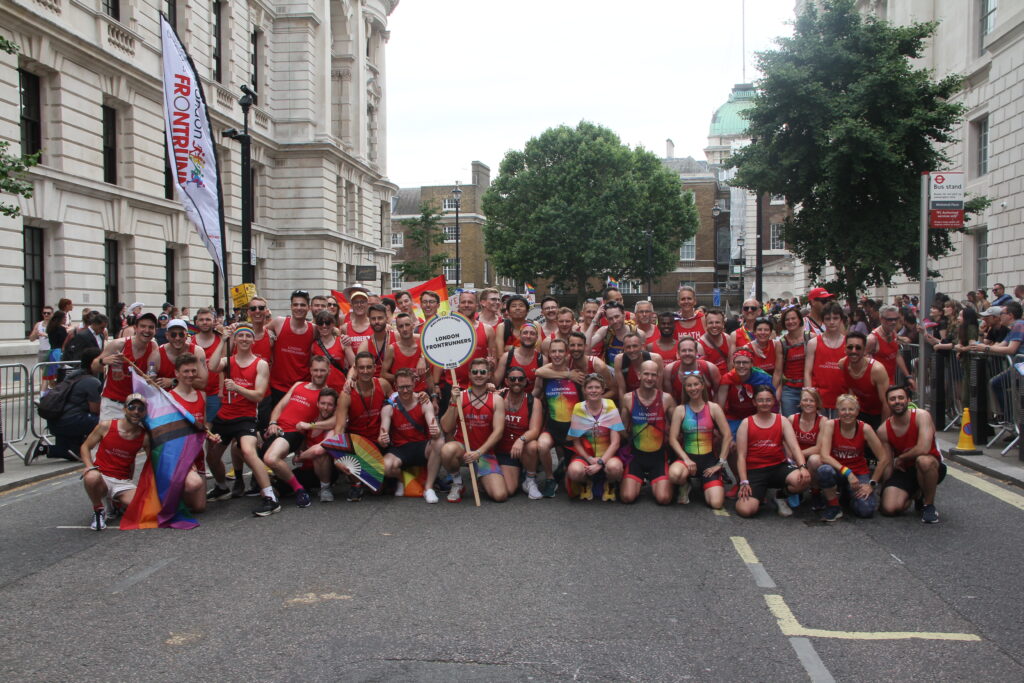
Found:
<box><xmin>441</xmin><ymin>358</ymin><xmax>509</xmax><ymax>503</ymax></box>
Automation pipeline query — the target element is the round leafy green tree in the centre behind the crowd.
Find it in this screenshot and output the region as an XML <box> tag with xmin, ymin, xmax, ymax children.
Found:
<box><xmin>482</xmin><ymin>122</ymin><xmax>697</xmax><ymax>294</ymax></box>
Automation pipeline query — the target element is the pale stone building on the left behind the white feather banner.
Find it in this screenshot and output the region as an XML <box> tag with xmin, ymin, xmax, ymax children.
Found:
<box><xmin>0</xmin><ymin>0</ymin><xmax>397</xmax><ymax>361</ymax></box>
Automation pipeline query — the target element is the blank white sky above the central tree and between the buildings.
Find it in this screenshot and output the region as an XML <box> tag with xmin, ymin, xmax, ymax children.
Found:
<box><xmin>386</xmin><ymin>0</ymin><xmax>796</xmax><ymax>187</ymax></box>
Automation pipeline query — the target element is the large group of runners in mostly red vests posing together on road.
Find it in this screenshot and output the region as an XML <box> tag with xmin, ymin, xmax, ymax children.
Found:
<box><xmin>36</xmin><ymin>280</ymin><xmax>1022</xmax><ymax>529</ymax></box>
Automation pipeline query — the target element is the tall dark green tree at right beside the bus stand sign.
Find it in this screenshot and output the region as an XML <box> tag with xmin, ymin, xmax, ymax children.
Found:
<box><xmin>731</xmin><ymin>0</ymin><xmax>986</xmax><ymax>299</ymax></box>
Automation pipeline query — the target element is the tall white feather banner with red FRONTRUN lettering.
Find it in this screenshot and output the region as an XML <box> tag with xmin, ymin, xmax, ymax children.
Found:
<box><xmin>160</xmin><ymin>14</ymin><xmax>224</xmax><ymax>273</ymax></box>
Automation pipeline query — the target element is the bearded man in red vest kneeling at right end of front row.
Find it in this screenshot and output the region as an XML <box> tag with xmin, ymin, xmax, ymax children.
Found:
<box><xmin>879</xmin><ymin>386</ymin><xmax>946</xmax><ymax>524</ymax></box>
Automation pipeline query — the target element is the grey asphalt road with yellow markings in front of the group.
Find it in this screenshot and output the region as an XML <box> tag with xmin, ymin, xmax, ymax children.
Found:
<box><xmin>0</xmin><ymin>462</ymin><xmax>1024</xmax><ymax>682</ymax></box>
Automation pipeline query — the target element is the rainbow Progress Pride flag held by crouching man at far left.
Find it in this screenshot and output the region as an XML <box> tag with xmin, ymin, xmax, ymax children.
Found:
<box><xmin>121</xmin><ymin>368</ymin><xmax>206</xmax><ymax>529</ymax></box>
